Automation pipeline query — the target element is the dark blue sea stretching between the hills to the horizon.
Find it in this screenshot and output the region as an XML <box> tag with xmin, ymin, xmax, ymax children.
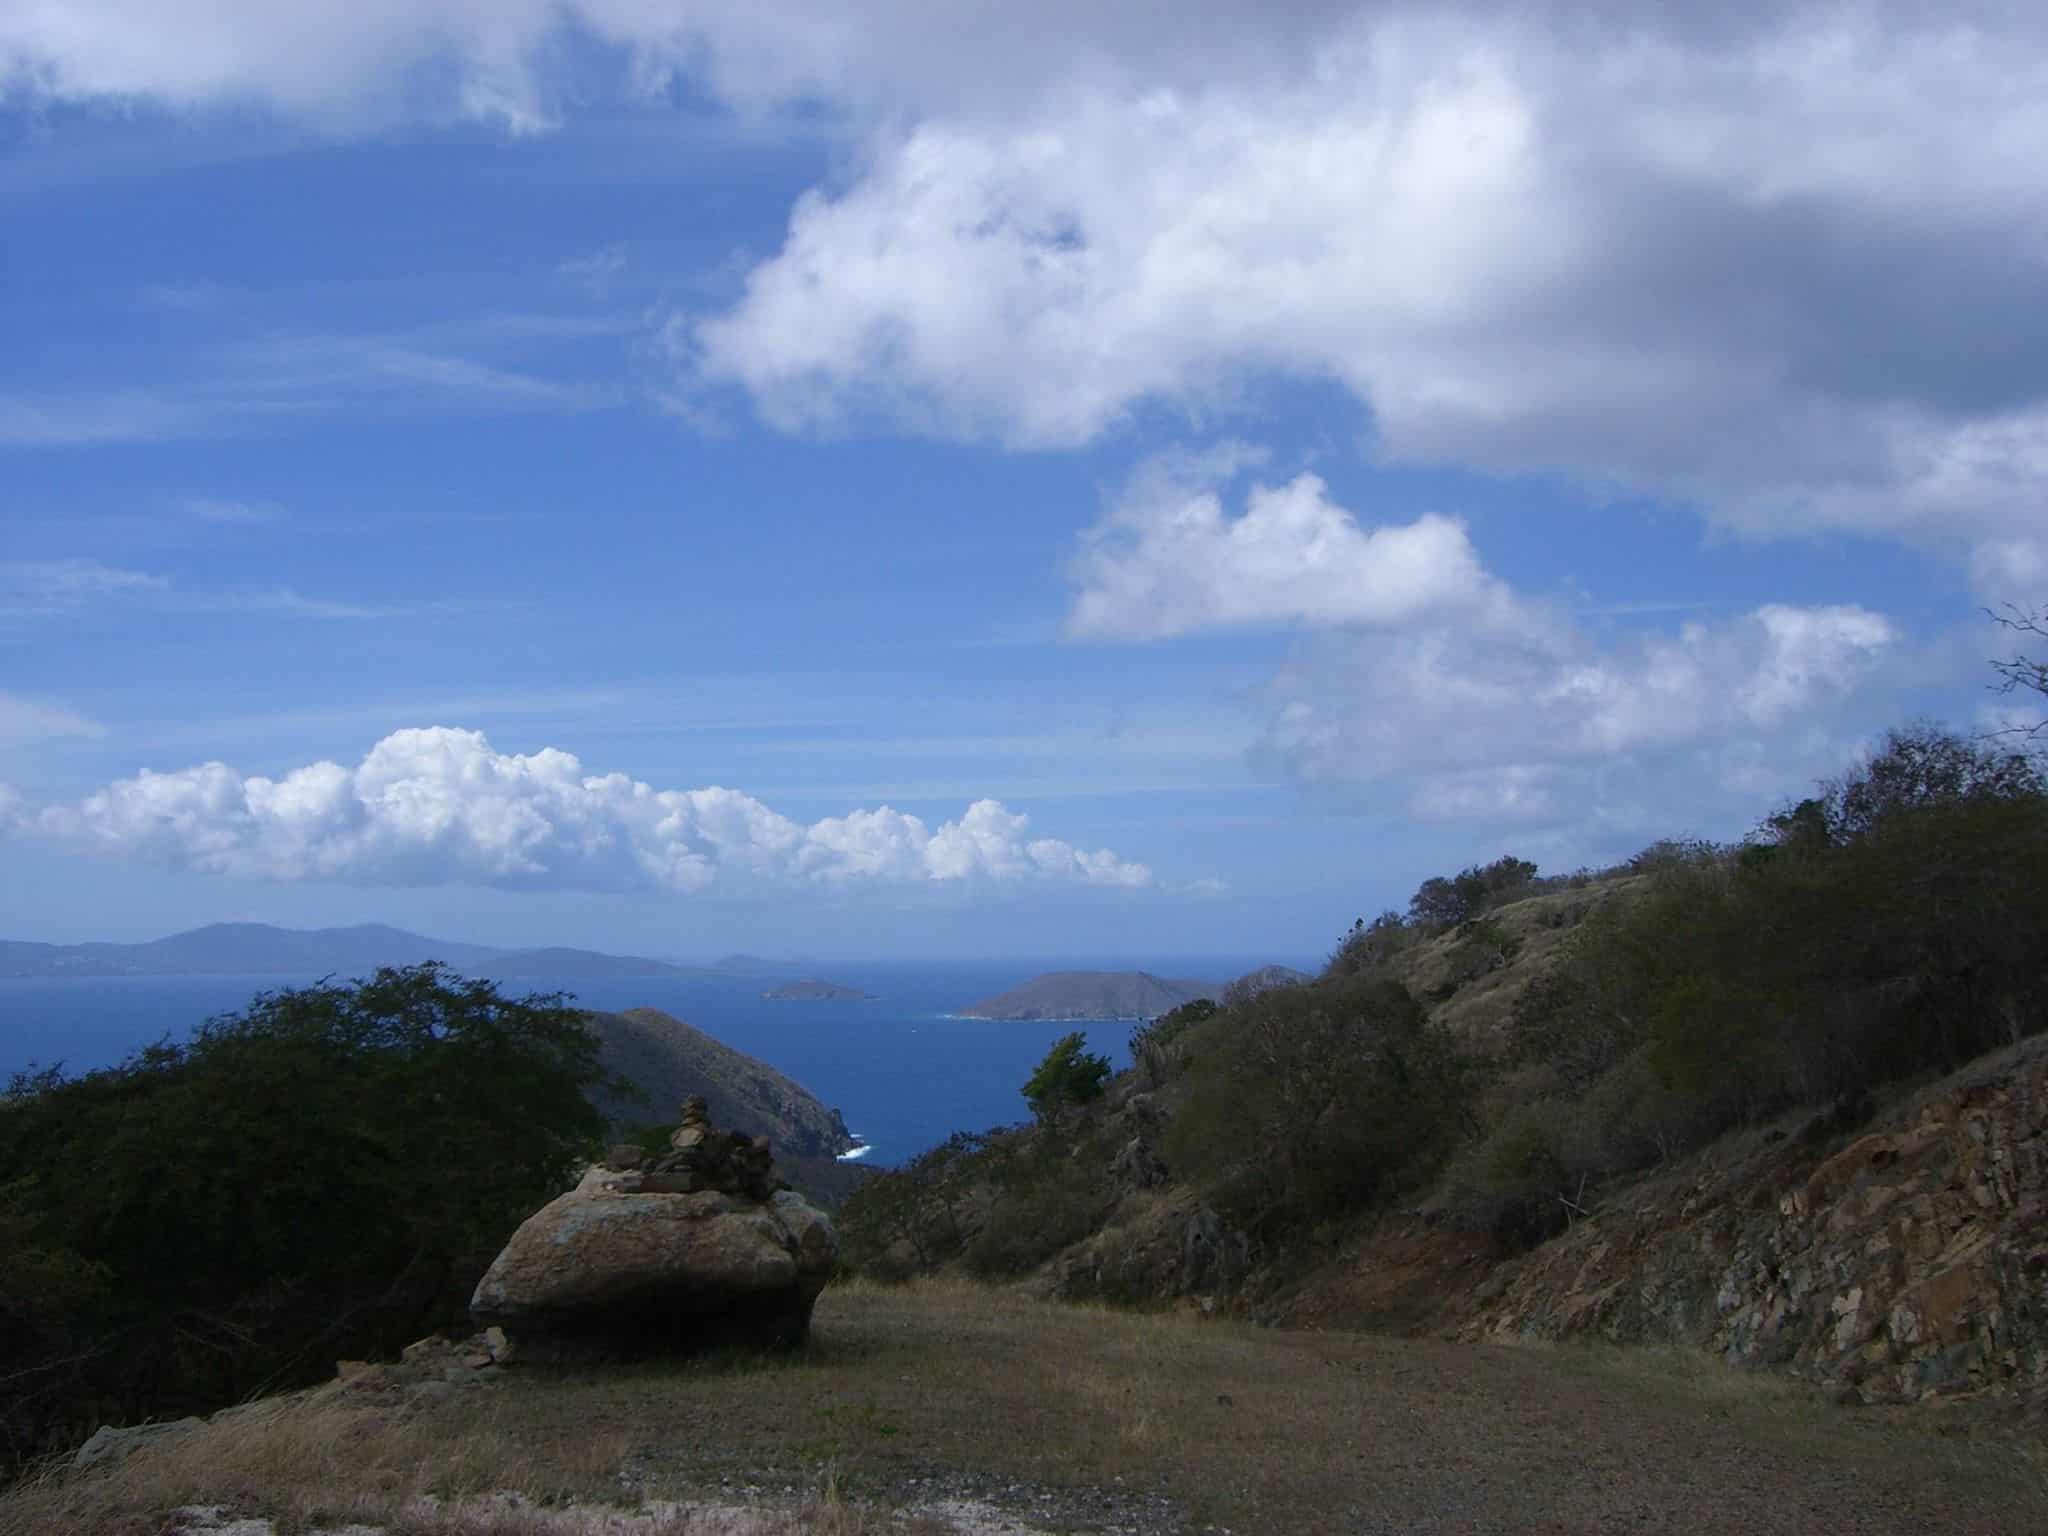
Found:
<box><xmin>0</xmin><ymin>954</ymin><xmax>1309</xmax><ymax>1165</ymax></box>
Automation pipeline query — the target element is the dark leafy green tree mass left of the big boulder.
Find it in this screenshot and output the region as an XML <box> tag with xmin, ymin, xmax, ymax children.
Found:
<box><xmin>0</xmin><ymin>965</ymin><xmax>602</xmax><ymax>1474</ymax></box>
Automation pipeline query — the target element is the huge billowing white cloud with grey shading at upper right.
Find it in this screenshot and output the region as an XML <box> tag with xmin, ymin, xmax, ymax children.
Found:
<box><xmin>676</xmin><ymin>4</ymin><xmax>2048</xmax><ymax>590</ymax></box>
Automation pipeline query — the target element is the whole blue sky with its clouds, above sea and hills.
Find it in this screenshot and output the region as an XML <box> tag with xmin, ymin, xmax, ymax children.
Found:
<box><xmin>0</xmin><ymin>0</ymin><xmax>2048</xmax><ymax>956</ymax></box>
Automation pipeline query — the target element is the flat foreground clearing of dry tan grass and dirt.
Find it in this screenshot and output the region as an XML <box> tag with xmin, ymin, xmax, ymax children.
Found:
<box><xmin>0</xmin><ymin>1284</ymin><xmax>2048</xmax><ymax>1536</ymax></box>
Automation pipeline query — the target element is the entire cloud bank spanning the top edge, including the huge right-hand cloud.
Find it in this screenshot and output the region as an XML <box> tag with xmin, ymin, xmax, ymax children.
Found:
<box><xmin>16</xmin><ymin>0</ymin><xmax>2048</xmax><ymax>581</ymax></box>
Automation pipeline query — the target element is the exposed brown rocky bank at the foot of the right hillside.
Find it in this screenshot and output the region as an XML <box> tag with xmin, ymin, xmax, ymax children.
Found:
<box><xmin>1460</xmin><ymin>1038</ymin><xmax>2048</xmax><ymax>1403</ymax></box>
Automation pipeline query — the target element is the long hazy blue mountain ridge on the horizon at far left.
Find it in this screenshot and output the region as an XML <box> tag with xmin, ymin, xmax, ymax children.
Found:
<box><xmin>0</xmin><ymin>924</ymin><xmax>723</xmax><ymax>979</ymax></box>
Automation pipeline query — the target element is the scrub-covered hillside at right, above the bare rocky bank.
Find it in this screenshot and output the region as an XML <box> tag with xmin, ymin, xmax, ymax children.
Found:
<box><xmin>844</xmin><ymin>727</ymin><xmax>2048</xmax><ymax>1311</ymax></box>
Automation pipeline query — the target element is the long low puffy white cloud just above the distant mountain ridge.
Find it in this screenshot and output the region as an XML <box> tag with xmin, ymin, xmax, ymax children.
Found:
<box><xmin>33</xmin><ymin>727</ymin><xmax>1153</xmax><ymax>891</ymax></box>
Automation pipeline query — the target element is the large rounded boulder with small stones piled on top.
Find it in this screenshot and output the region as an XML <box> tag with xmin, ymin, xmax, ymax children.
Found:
<box><xmin>469</xmin><ymin>1098</ymin><xmax>838</xmax><ymax>1360</ymax></box>
